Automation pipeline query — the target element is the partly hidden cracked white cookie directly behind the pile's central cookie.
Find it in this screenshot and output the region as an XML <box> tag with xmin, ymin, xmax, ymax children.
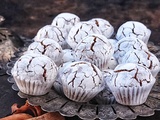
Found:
<box><xmin>66</xmin><ymin>22</ymin><xmax>101</xmax><ymax>49</ymax></box>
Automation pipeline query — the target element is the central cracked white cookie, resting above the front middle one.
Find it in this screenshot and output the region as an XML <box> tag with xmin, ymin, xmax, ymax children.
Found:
<box><xmin>75</xmin><ymin>34</ymin><xmax>114</xmax><ymax>70</ymax></box>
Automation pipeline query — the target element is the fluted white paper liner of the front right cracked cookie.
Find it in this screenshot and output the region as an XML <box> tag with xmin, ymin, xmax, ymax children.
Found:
<box><xmin>110</xmin><ymin>82</ymin><xmax>154</xmax><ymax>105</ymax></box>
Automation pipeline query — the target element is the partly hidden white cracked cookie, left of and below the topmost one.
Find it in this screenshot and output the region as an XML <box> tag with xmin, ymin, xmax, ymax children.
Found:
<box><xmin>34</xmin><ymin>25</ymin><xmax>69</xmax><ymax>48</ymax></box>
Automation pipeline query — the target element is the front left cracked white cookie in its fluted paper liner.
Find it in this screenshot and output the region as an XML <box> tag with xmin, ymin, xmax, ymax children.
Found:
<box><xmin>12</xmin><ymin>53</ymin><xmax>58</xmax><ymax>95</ymax></box>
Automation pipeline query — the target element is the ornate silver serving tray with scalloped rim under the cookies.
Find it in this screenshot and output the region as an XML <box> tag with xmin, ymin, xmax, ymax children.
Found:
<box><xmin>7</xmin><ymin>42</ymin><xmax>160</xmax><ymax>120</ymax></box>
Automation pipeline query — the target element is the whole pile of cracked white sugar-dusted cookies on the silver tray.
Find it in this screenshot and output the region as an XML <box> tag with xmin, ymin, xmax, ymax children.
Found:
<box><xmin>12</xmin><ymin>13</ymin><xmax>160</xmax><ymax>105</ymax></box>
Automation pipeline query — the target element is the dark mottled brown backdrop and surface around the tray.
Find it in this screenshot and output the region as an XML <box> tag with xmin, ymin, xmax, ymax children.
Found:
<box><xmin>0</xmin><ymin>0</ymin><xmax>160</xmax><ymax>120</ymax></box>
